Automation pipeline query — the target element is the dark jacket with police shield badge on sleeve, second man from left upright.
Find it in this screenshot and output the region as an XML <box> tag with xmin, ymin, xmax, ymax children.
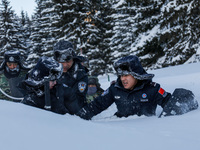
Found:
<box><xmin>58</xmin><ymin>61</ymin><xmax>88</xmax><ymax>114</ymax></box>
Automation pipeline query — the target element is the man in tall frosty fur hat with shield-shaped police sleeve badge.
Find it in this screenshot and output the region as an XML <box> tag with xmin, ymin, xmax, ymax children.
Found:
<box><xmin>54</xmin><ymin>40</ymin><xmax>88</xmax><ymax>115</ymax></box>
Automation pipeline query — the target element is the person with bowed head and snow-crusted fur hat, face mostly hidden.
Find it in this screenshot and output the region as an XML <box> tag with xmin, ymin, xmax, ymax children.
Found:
<box><xmin>20</xmin><ymin>56</ymin><xmax>68</xmax><ymax>114</ymax></box>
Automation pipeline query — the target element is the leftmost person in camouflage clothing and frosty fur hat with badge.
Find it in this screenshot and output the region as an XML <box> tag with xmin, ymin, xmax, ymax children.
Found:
<box><xmin>0</xmin><ymin>50</ymin><xmax>30</xmax><ymax>100</ymax></box>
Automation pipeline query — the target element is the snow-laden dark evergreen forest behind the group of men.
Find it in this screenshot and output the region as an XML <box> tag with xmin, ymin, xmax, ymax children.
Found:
<box><xmin>0</xmin><ymin>0</ymin><xmax>200</xmax><ymax>75</ymax></box>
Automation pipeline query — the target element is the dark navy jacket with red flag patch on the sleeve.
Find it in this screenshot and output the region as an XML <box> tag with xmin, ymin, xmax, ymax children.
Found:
<box><xmin>77</xmin><ymin>78</ymin><xmax>171</xmax><ymax>119</ymax></box>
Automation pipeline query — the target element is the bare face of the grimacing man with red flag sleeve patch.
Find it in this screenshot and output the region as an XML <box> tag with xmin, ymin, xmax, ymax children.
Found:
<box><xmin>120</xmin><ymin>74</ymin><xmax>138</xmax><ymax>90</ymax></box>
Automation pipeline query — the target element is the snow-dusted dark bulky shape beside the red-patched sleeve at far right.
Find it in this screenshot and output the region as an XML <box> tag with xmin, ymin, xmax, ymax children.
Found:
<box><xmin>159</xmin><ymin>88</ymin><xmax>198</xmax><ymax>117</ymax></box>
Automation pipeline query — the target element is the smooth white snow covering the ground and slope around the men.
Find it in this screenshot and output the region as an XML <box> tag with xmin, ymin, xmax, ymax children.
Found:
<box><xmin>0</xmin><ymin>63</ymin><xmax>200</xmax><ymax>150</ymax></box>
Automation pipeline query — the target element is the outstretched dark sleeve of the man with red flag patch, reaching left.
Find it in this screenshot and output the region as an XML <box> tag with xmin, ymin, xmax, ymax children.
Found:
<box><xmin>76</xmin><ymin>87</ymin><xmax>114</xmax><ymax>120</ymax></box>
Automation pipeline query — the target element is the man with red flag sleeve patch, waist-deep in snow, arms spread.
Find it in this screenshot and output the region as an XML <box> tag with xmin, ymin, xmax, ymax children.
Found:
<box><xmin>77</xmin><ymin>55</ymin><xmax>198</xmax><ymax>120</ymax></box>
